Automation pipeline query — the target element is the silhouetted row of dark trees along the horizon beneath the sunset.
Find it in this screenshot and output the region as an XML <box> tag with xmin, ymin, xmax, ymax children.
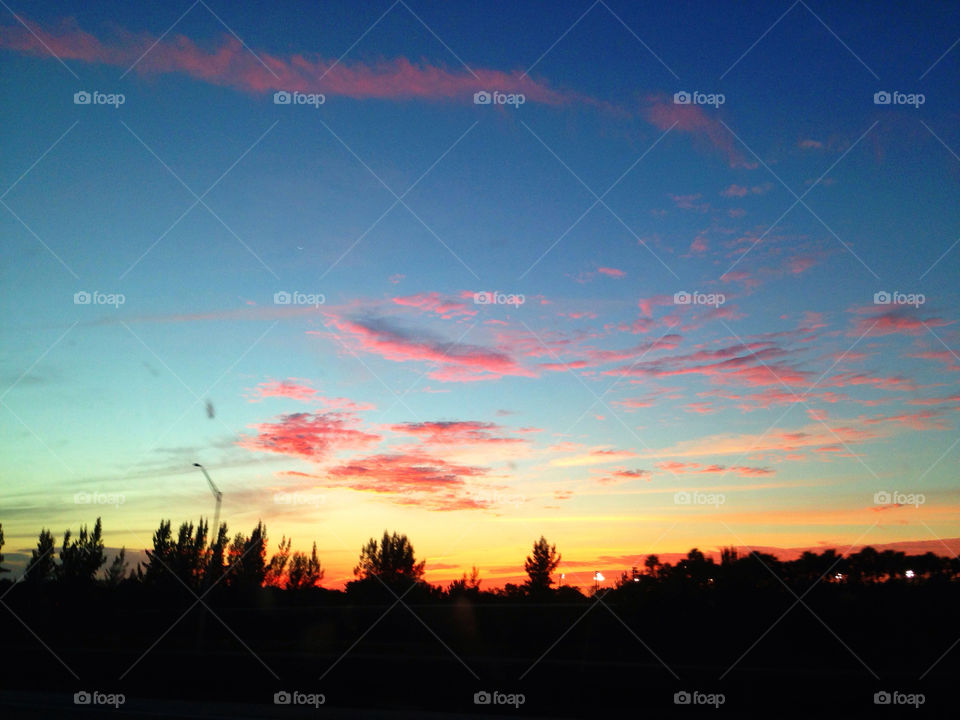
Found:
<box><xmin>0</xmin><ymin>518</ymin><xmax>960</xmax><ymax>598</ymax></box>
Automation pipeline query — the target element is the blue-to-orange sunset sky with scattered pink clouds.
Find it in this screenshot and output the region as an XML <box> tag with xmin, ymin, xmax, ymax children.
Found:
<box><xmin>0</xmin><ymin>0</ymin><xmax>960</xmax><ymax>587</ymax></box>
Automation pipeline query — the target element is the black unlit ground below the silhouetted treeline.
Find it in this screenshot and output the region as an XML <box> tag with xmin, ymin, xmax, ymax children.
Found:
<box><xmin>0</xmin><ymin>582</ymin><xmax>960</xmax><ymax>720</ymax></box>
